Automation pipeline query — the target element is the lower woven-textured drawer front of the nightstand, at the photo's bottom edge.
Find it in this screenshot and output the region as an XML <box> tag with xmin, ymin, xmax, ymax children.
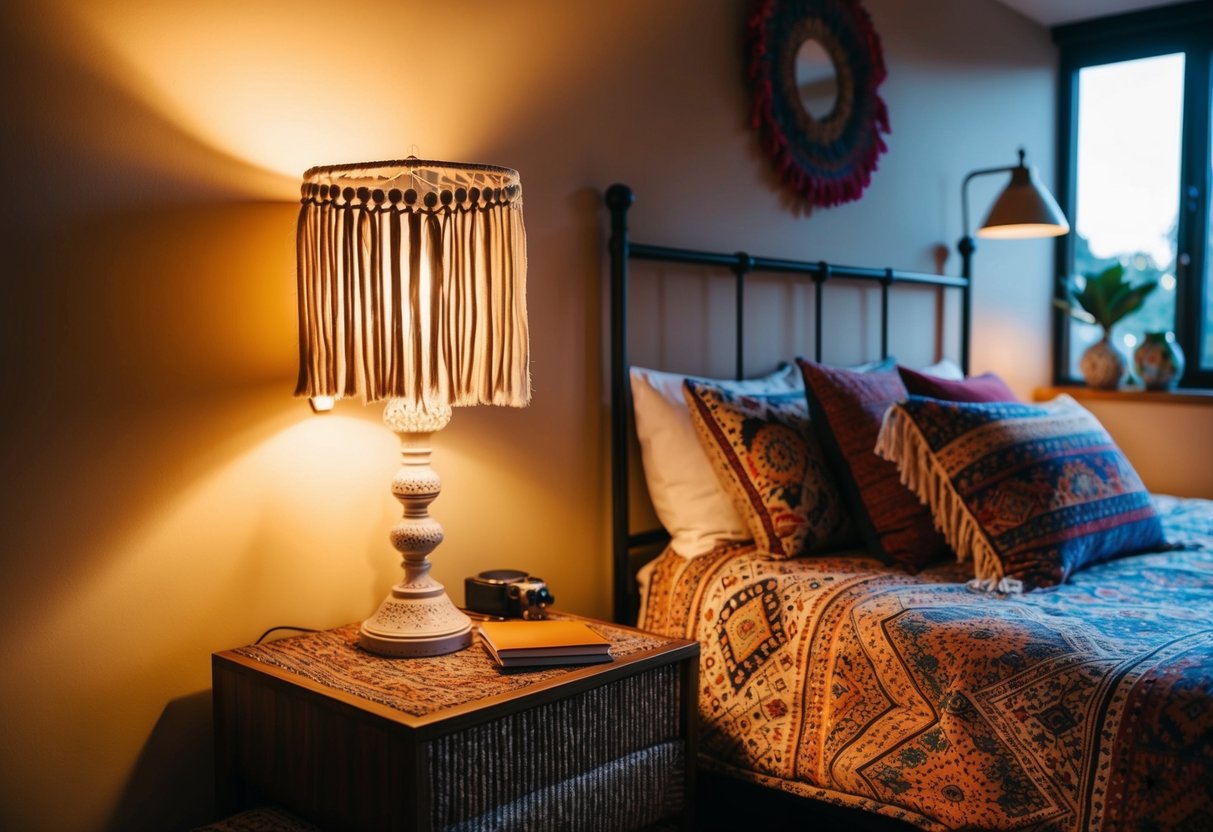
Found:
<box><xmin>445</xmin><ymin>741</ymin><xmax>687</xmax><ymax>832</ymax></box>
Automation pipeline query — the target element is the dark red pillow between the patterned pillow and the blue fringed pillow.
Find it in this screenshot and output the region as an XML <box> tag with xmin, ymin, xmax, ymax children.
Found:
<box><xmin>796</xmin><ymin>358</ymin><xmax>949</xmax><ymax>572</ymax></box>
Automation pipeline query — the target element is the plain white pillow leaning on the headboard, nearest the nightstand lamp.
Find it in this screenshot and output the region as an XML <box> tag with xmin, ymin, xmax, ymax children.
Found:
<box><xmin>632</xmin><ymin>364</ymin><xmax>804</xmax><ymax>557</ymax></box>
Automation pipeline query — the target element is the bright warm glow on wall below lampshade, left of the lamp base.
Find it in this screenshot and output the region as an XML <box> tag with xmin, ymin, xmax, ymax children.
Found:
<box><xmin>29</xmin><ymin>401</ymin><xmax>394</xmax><ymax>659</ymax></box>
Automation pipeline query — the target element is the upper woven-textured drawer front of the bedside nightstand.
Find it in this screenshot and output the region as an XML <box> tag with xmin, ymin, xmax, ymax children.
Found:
<box><xmin>428</xmin><ymin>665</ymin><xmax>682</xmax><ymax>828</ymax></box>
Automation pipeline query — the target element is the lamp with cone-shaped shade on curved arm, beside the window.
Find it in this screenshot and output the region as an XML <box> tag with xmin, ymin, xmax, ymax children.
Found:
<box><xmin>956</xmin><ymin>148</ymin><xmax>1070</xmax><ymax>372</ymax></box>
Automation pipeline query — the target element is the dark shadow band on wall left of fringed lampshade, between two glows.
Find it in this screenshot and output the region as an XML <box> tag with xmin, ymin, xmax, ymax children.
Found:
<box><xmin>0</xmin><ymin>4</ymin><xmax>303</xmax><ymax>615</ymax></box>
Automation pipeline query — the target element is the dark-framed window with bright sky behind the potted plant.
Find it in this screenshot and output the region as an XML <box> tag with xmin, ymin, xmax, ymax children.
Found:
<box><xmin>1053</xmin><ymin>1</ymin><xmax>1213</xmax><ymax>387</ymax></box>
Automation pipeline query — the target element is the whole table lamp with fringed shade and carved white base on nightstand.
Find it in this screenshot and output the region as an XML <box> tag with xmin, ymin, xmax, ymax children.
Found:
<box><xmin>295</xmin><ymin>158</ymin><xmax>530</xmax><ymax>656</ymax></box>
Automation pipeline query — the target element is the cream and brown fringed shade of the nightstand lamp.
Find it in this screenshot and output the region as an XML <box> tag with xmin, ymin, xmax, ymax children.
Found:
<box><xmin>295</xmin><ymin>158</ymin><xmax>530</xmax><ymax>410</ymax></box>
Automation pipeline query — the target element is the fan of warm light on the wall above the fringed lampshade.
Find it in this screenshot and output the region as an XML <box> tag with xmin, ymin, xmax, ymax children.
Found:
<box><xmin>66</xmin><ymin>0</ymin><xmax>623</xmax><ymax>185</ymax></box>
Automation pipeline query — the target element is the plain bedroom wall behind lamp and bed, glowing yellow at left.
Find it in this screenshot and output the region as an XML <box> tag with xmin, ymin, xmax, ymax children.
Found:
<box><xmin>0</xmin><ymin>0</ymin><xmax>1203</xmax><ymax>832</ymax></box>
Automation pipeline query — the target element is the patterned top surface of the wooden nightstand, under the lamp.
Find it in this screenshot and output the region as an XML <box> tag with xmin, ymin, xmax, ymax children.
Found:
<box><xmin>215</xmin><ymin>614</ymin><xmax>699</xmax><ymax>736</ymax></box>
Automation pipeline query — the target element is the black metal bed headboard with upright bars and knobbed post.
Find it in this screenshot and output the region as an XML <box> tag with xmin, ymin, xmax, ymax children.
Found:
<box><xmin>605</xmin><ymin>184</ymin><xmax>970</xmax><ymax>623</ymax></box>
